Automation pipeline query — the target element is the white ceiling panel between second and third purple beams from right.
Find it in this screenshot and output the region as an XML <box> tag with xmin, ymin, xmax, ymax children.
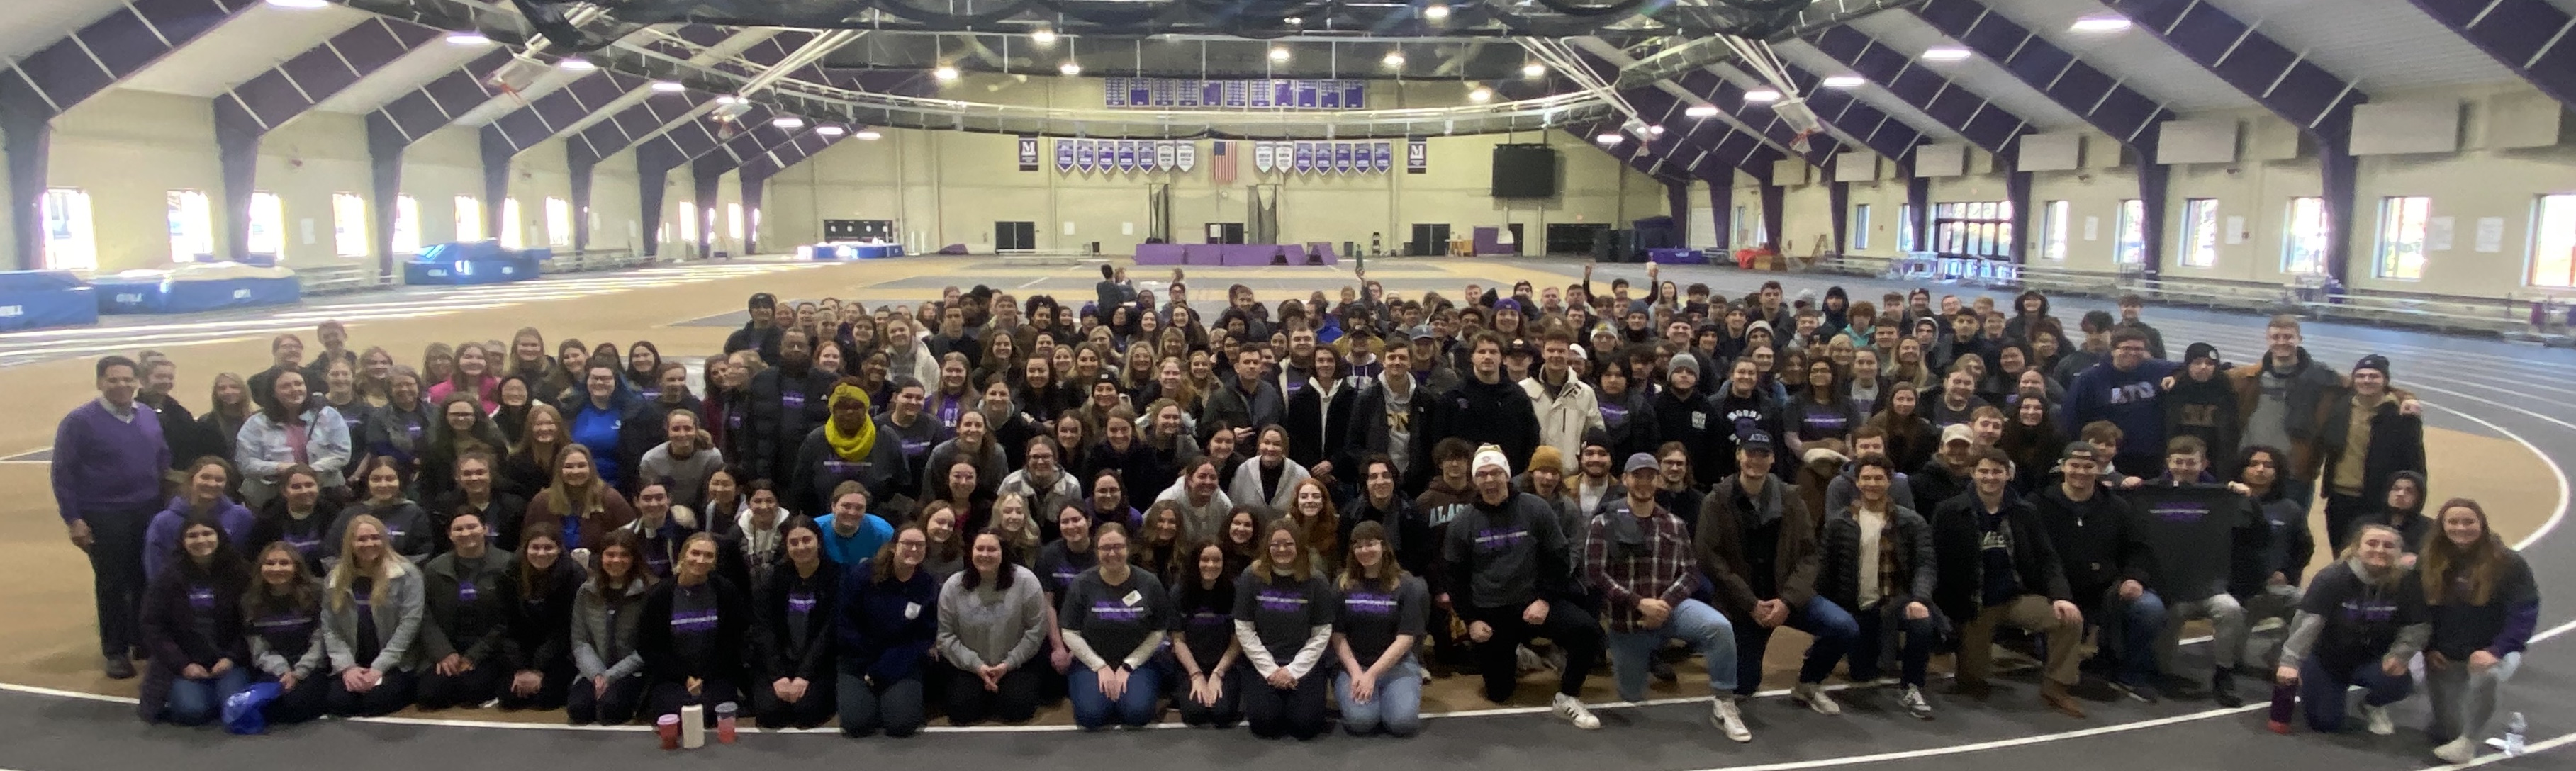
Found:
<box><xmin>1986</xmin><ymin>0</ymin><xmax>2256</xmax><ymax>113</ymax></box>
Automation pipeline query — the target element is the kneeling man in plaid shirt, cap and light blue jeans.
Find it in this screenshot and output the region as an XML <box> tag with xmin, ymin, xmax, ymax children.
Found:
<box><xmin>1581</xmin><ymin>454</ymin><xmax>1754</xmax><ymax>743</ymax></box>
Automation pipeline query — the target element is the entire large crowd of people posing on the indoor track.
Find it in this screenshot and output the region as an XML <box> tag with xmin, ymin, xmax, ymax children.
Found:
<box><xmin>52</xmin><ymin>268</ymin><xmax>2540</xmax><ymax>760</ymax></box>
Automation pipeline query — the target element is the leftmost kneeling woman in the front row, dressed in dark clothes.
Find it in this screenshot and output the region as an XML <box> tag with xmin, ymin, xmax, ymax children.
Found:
<box><xmin>137</xmin><ymin>516</ymin><xmax>250</xmax><ymax>725</ymax></box>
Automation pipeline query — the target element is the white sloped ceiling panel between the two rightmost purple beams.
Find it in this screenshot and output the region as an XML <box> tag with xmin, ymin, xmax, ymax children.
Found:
<box><xmin>2202</xmin><ymin>0</ymin><xmax>2514</xmax><ymax>93</ymax></box>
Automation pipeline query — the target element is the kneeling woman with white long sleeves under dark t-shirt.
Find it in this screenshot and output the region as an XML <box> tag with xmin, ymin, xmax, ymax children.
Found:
<box><xmin>1234</xmin><ymin>518</ymin><xmax>1334</xmax><ymax>740</ymax></box>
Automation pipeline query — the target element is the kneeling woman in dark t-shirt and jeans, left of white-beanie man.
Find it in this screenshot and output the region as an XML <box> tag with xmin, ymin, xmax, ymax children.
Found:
<box><xmin>1332</xmin><ymin>521</ymin><xmax>1433</xmax><ymax>738</ymax></box>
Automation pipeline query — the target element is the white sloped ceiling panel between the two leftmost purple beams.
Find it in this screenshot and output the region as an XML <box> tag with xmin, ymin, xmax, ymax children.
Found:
<box><xmin>119</xmin><ymin>0</ymin><xmax>374</xmax><ymax>98</ymax></box>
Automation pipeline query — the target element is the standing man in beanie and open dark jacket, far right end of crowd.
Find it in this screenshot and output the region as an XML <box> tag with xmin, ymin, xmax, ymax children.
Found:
<box><xmin>2316</xmin><ymin>354</ymin><xmax>2424</xmax><ymax>552</ymax></box>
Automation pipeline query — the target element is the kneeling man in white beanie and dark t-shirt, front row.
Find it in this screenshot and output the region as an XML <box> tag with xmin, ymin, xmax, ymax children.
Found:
<box><xmin>1440</xmin><ymin>446</ymin><xmax>1602</xmax><ymax>730</ymax></box>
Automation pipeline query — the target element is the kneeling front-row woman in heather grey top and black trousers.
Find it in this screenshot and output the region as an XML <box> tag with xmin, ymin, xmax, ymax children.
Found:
<box><xmin>938</xmin><ymin>531</ymin><xmax>1048</xmax><ymax>725</ymax></box>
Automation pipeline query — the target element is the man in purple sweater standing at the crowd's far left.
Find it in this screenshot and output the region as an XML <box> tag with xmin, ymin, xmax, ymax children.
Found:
<box><xmin>54</xmin><ymin>356</ymin><xmax>170</xmax><ymax>681</ymax></box>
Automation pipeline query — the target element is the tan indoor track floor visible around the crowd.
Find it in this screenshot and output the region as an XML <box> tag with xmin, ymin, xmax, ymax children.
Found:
<box><xmin>0</xmin><ymin>261</ymin><xmax>2558</xmax><ymax>725</ymax></box>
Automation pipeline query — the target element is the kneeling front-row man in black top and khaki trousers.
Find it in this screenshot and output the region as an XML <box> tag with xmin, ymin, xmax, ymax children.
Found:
<box><xmin>1932</xmin><ymin>446</ymin><xmax>2084</xmax><ymax>717</ymax></box>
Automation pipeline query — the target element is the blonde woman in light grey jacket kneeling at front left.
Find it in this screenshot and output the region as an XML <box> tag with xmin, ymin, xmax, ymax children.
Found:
<box><xmin>322</xmin><ymin>513</ymin><xmax>425</xmax><ymax>717</ymax></box>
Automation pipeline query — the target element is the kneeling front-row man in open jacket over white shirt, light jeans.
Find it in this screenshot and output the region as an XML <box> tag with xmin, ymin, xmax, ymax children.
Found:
<box><xmin>1816</xmin><ymin>451</ymin><xmax>1947</xmax><ymax>719</ymax></box>
